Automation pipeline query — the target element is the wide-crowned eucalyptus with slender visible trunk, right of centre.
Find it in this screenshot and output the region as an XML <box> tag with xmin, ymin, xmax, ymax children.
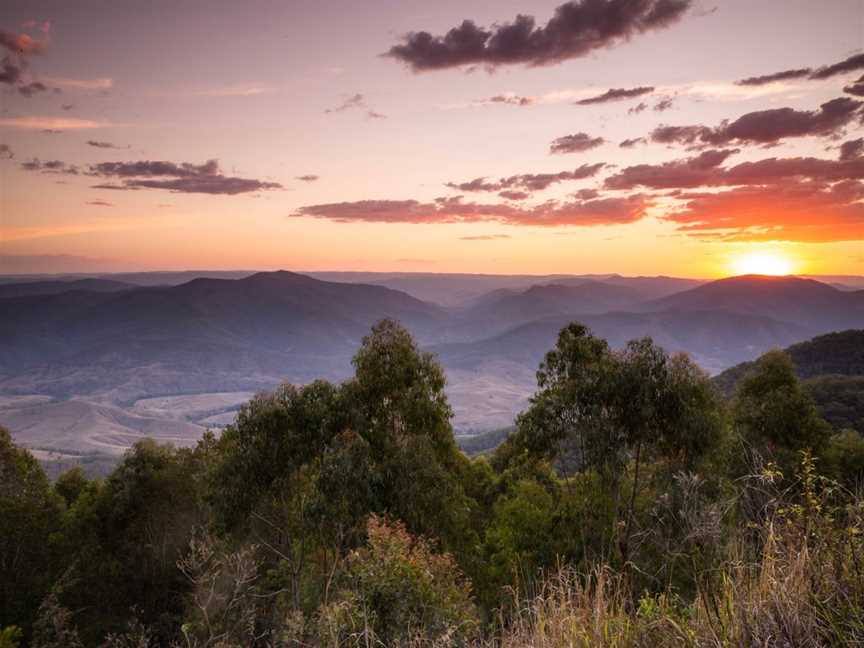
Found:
<box><xmin>509</xmin><ymin>322</ymin><xmax>721</xmax><ymax>563</ymax></box>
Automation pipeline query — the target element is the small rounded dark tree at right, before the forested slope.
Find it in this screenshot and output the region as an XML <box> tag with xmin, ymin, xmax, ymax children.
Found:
<box><xmin>733</xmin><ymin>351</ymin><xmax>831</xmax><ymax>475</ymax></box>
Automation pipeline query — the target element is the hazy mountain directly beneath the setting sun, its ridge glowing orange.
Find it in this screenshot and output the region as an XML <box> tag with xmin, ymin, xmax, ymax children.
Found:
<box><xmin>640</xmin><ymin>275</ymin><xmax>864</xmax><ymax>337</ymax></box>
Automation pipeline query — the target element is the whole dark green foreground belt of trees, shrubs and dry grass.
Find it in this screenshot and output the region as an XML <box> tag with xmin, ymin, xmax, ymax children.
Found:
<box><xmin>0</xmin><ymin>321</ymin><xmax>864</xmax><ymax>648</ymax></box>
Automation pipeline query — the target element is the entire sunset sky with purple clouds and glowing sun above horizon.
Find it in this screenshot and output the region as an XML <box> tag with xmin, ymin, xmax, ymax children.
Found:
<box><xmin>0</xmin><ymin>0</ymin><xmax>864</xmax><ymax>278</ymax></box>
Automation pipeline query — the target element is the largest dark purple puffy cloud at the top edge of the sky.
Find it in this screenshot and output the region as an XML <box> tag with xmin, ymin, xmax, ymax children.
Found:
<box><xmin>385</xmin><ymin>0</ymin><xmax>691</xmax><ymax>72</ymax></box>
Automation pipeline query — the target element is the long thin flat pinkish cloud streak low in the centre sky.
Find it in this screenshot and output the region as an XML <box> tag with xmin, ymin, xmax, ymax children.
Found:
<box><xmin>292</xmin><ymin>194</ymin><xmax>649</xmax><ymax>227</ymax></box>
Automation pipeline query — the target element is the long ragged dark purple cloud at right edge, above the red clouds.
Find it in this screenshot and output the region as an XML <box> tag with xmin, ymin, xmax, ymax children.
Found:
<box><xmin>651</xmin><ymin>97</ymin><xmax>864</xmax><ymax>146</ymax></box>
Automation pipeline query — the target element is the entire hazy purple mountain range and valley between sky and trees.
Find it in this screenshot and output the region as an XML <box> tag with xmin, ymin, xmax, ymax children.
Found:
<box><xmin>0</xmin><ymin>271</ymin><xmax>864</xmax><ymax>451</ymax></box>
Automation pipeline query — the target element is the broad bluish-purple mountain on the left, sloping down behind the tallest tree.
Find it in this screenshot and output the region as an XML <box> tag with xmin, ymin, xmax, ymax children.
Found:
<box><xmin>0</xmin><ymin>272</ymin><xmax>445</xmax><ymax>400</ymax></box>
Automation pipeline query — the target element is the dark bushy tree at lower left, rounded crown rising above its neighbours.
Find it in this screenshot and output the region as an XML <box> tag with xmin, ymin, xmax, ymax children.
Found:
<box><xmin>59</xmin><ymin>439</ymin><xmax>206</xmax><ymax>645</ymax></box>
